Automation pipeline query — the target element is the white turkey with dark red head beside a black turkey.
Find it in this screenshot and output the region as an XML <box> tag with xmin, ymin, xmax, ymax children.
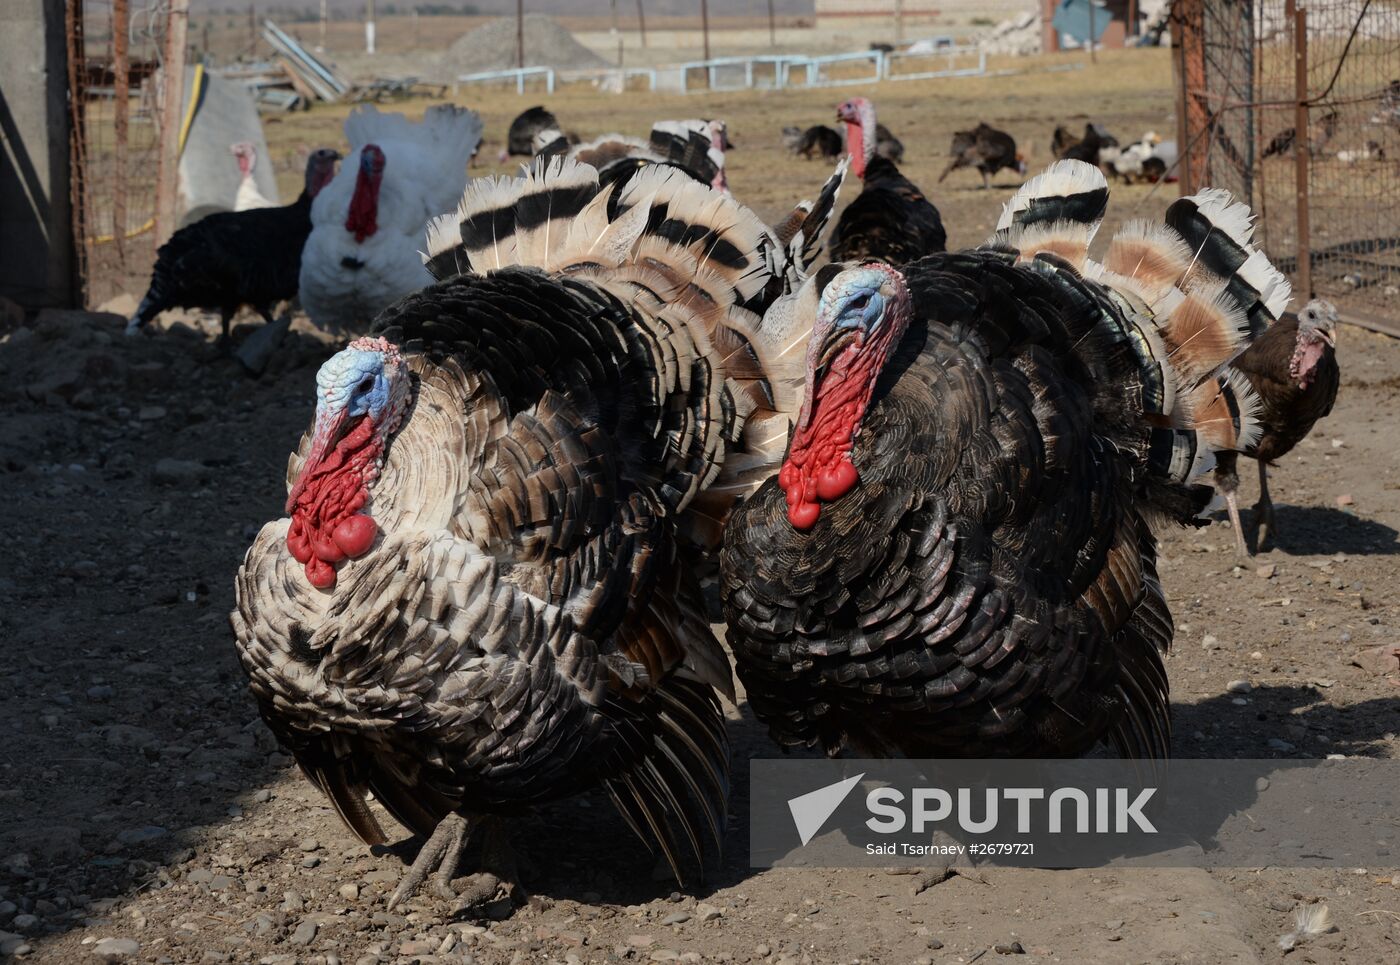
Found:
<box><xmin>301</xmin><ymin>104</ymin><xmax>482</xmax><ymax>332</ymax></box>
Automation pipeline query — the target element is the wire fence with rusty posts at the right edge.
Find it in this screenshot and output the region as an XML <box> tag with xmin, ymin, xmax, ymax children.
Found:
<box><xmin>1173</xmin><ymin>0</ymin><xmax>1400</xmax><ymax>319</ymax></box>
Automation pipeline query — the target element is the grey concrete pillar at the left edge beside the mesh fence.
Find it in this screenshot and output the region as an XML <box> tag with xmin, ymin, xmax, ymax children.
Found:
<box><xmin>0</xmin><ymin>0</ymin><xmax>77</xmax><ymax>308</ymax></box>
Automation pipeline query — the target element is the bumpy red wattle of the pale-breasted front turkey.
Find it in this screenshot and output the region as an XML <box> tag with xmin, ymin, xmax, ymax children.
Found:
<box><xmin>287</xmin><ymin>416</ymin><xmax>384</xmax><ymax>590</ymax></box>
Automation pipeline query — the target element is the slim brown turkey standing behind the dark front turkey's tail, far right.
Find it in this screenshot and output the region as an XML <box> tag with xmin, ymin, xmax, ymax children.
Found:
<box><xmin>1215</xmin><ymin>298</ymin><xmax>1341</xmax><ymax>559</ymax></box>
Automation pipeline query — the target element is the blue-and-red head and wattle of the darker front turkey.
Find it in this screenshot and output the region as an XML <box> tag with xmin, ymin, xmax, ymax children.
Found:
<box><xmin>778</xmin><ymin>263</ymin><xmax>909</xmax><ymax>529</ymax></box>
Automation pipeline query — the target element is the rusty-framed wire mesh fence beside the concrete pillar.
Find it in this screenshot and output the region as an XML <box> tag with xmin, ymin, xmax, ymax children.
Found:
<box><xmin>69</xmin><ymin>0</ymin><xmax>169</xmax><ymax>304</ymax></box>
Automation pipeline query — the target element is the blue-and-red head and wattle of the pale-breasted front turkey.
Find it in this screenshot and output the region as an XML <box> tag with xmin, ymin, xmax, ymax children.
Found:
<box><xmin>287</xmin><ymin>338</ymin><xmax>412</xmax><ymax>590</ymax></box>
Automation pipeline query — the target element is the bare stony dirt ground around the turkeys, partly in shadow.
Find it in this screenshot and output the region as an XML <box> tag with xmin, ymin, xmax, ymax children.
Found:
<box><xmin>0</xmin><ymin>55</ymin><xmax>1400</xmax><ymax>965</ymax></box>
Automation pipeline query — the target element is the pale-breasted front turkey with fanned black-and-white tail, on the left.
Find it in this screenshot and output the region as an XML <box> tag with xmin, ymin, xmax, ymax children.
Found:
<box><xmin>232</xmin><ymin>158</ymin><xmax>841</xmax><ymax>906</ymax></box>
